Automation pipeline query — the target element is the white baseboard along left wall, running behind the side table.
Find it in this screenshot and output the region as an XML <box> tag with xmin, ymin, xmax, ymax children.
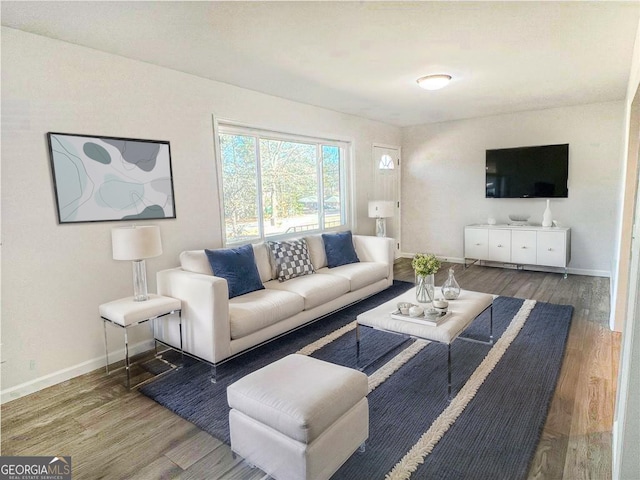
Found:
<box><xmin>0</xmin><ymin>340</ymin><xmax>154</xmax><ymax>404</ymax></box>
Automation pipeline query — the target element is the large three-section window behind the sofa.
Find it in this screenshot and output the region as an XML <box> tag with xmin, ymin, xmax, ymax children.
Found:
<box><xmin>219</xmin><ymin>125</ymin><xmax>349</xmax><ymax>244</ymax></box>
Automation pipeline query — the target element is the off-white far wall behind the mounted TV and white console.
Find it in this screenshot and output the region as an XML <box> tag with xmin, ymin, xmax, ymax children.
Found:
<box><xmin>402</xmin><ymin>102</ymin><xmax>624</xmax><ymax>276</ymax></box>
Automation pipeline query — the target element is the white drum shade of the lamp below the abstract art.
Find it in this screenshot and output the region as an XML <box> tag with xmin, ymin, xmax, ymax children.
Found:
<box><xmin>111</xmin><ymin>225</ymin><xmax>162</xmax><ymax>260</ymax></box>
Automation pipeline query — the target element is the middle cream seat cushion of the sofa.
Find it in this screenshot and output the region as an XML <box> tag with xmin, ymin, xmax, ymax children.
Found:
<box><xmin>264</xmin><ymin>275</ymin><xmax>349</xmax><ymax>310</ymax></box>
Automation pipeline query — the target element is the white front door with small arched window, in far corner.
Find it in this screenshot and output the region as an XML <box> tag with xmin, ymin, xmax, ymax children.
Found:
<box><xmin>369</xmin><ymin>145</ymin><xmax>400</xmax><ymax>258</ymax></box>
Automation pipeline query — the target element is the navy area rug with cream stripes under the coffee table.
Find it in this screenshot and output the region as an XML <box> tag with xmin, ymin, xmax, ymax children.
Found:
<box><xmin>141</xmin><ymin>282</ymin><xmax>573</xmax><ymax>480</ymax></box>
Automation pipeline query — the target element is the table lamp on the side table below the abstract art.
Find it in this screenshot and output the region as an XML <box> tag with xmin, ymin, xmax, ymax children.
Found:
<box><xmin>111</xmin><ymin>225</ymin><xmax>162</xmax><ymax>302</ymax></box>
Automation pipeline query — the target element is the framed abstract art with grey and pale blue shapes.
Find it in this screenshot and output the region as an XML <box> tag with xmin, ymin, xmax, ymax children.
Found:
<box><xmin>47</xmin><ymin>132</ymin><xmax>176</xmax><ymax>224</ymax></box>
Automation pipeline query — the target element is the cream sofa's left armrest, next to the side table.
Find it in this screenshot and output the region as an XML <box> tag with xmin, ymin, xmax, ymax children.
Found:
<box><xmin>156</xmin><ymin>268</ymin><xmax>231</xmax><ymax>363</ymax></box>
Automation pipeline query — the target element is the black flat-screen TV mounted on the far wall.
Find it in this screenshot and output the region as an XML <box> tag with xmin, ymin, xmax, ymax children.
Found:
<box><xmin>486</xmin><ymin>143</ymin><xmax>569</xmax><ymax>198</ymax></box>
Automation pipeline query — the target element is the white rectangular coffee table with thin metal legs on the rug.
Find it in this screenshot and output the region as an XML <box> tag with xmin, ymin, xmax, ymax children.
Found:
<box><xmin>356</xmin><ymin>288</ymin><xmax>494</xmax><ymax>398</ymax></box>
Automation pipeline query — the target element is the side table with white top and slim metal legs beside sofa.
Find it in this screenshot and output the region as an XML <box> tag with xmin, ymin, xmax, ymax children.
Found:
<box><xmin>98</xmin><ymin>294</ymin><xmax>184</xmax><ymax>389</ymax></box>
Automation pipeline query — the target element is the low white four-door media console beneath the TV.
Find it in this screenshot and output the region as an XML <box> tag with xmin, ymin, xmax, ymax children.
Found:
<box><xmin>464</xmin><ymin>225</ymin><xmax>571</xmax><ymax>277</ymax></box>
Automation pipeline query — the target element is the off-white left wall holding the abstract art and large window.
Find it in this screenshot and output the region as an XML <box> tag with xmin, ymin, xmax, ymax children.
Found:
<box><xmin>1</xmin><ymin>28</ymin><xmax>401</xmax><ymax>400</ymax></box>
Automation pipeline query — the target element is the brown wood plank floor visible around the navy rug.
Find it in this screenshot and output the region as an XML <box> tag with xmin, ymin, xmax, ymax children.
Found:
<box><xmin>1</xmin><ymin>259</ymin><xmax>620</xmax><ymax>480</ymax></box>
